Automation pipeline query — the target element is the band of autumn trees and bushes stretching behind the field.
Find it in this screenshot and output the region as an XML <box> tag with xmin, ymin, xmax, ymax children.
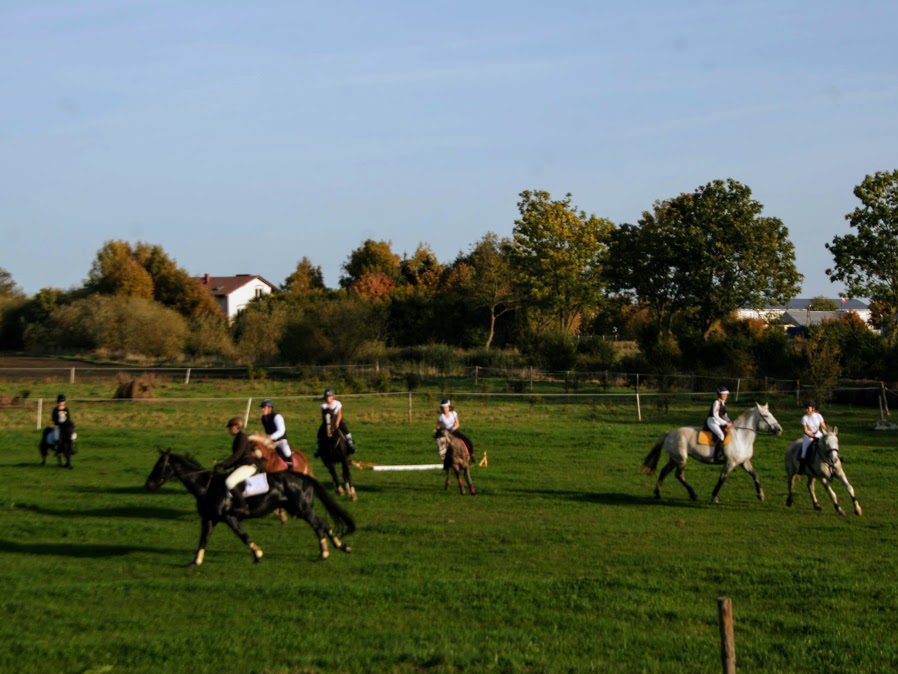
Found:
<box><xmin>0</xmin><ymin>170</ymin><xmax>898</xmax><ymax>392</ymax></box>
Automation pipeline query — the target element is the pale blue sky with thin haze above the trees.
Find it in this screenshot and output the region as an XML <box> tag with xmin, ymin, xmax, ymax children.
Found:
<box><xmin>0</xmin><ymin>0</ymin><xmax>898</xmax><ymax>297</ymax></box>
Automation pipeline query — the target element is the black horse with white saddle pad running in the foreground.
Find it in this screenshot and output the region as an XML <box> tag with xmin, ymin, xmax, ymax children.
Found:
<box><xmin>146</xmin><ymin>449</ymin><xmax>355</xmax><ymax>566</ymax></box>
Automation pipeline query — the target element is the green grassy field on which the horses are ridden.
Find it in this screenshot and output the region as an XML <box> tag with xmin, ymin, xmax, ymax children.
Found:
<box><xmin>0</xmin><ymin>382</ymin><xmax>898</xmax><ymax>674</ymax></box>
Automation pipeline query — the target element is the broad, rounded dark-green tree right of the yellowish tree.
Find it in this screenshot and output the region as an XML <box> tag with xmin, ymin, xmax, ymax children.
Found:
<box><xmin>607</xmin><ymin>179</ymin><xmax>803</xmax><ymax>337</ymax></box>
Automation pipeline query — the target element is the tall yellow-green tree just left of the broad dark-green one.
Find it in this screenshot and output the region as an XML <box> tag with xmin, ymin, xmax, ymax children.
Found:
<box><xmin>510</xmin><ymin>190</ymin><xmax>614</xmax><ymax>334</ymax></box>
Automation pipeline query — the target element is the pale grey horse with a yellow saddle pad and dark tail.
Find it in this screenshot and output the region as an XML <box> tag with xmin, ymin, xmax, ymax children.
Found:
<box><xmin>641</xmin><ymin>403</ymin><xmax>783</xmax><ymax>503</ymax></box>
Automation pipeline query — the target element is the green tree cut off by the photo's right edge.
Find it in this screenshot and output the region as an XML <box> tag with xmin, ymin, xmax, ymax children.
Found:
<box><xmin>826</xmin><ymin>169</ymin><xmax>898</xmax><ymax>336</ymax></box>
